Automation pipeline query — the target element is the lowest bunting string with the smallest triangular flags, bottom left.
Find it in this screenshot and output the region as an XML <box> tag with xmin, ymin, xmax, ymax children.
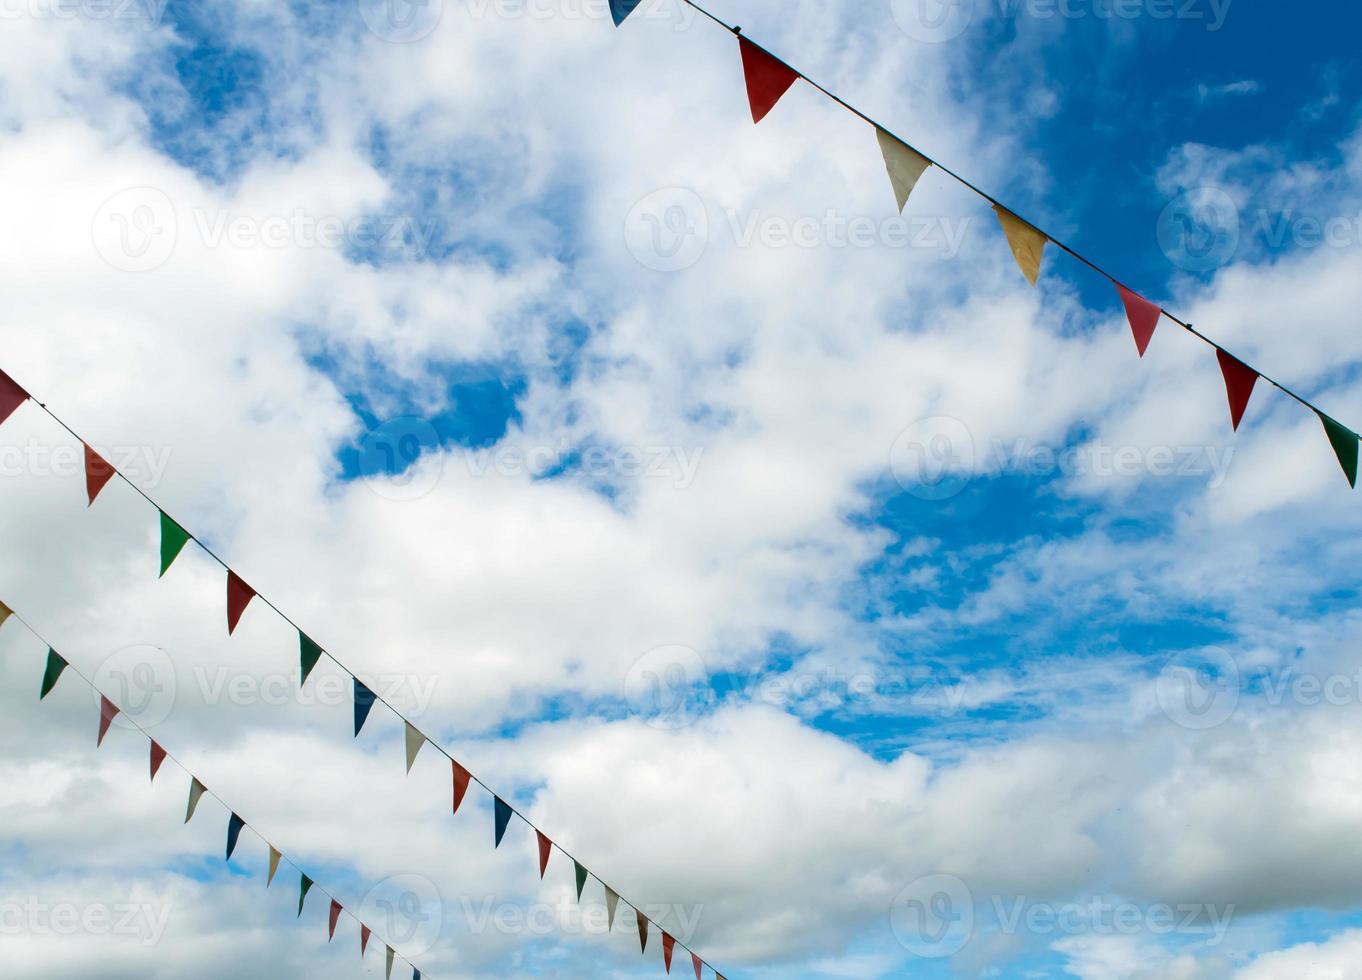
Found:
<box><xmin>0</xmin><ymin>602</ymin><xmax>422</xmax><ymax>980</ymax></box>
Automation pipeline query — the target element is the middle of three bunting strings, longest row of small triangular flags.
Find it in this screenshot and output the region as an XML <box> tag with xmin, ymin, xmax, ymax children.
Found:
<box><xmin>0</xmin><ymin>369</ymin><xmax>725</xmax><ymax>980</ymax></box>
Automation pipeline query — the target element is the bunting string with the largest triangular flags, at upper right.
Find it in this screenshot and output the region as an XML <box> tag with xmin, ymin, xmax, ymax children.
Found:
<box><xmin>610</xmin><ymin>0</ymin><xmax>1359</xmax><ymax>489</ymax></box>
